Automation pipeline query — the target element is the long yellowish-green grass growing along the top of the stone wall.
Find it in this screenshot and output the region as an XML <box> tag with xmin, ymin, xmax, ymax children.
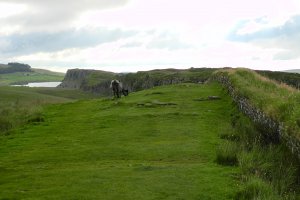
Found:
<box><xmin>214</xmin><ymin>69</ymin><xmax>300</xmax><ymax>139</ymax></box>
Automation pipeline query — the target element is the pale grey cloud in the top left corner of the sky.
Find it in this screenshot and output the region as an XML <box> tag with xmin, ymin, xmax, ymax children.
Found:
<box><xmin>0</xmin><ymin>0</ymin><xmax>129</xmax><ymax>32</ymax></box>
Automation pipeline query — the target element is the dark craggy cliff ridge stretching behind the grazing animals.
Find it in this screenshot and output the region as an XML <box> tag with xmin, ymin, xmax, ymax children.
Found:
<box><xmin>60</xmin><ymin>68</ymin><xmax>216</xmax><ymax>96</ymax></box>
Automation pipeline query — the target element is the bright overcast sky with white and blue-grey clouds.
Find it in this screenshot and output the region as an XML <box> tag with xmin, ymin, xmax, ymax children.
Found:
<box><xmin>0</xmin><ymin>0</ymin><xmax>300</xmax><ymax>72</ymax></box>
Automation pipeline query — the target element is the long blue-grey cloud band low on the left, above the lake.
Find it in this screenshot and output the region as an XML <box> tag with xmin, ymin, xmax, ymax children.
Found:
<box><xmin>0</xmin><ymin>28</ymin><xmax>137</xmax><ymax>55</ymax></box>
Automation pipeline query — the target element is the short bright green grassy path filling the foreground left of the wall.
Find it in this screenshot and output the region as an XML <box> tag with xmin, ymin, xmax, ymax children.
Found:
<box><xmin>0</xmin><ymin>84</ymin><xmax>237</xmax><ymax>200</ymax></box>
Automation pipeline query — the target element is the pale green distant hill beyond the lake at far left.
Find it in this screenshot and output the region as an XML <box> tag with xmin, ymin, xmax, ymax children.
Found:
<box><xmin>0</xmin><ymin>63</ymin><xmax>64</xmax><ymax>86</ymax></box>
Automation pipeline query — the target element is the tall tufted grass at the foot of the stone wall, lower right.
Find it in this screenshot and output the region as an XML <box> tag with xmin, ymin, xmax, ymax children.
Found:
<box><xmin>217</xmin><ymin>105</ymin><xmax>300</xmax><ymax>200</ymax></box>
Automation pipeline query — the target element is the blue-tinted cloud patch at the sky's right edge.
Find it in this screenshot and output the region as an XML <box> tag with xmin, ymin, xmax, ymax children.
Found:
<box><xmin>228</xmin><ymin>15</ymin><xmax>300</xmax><ymax>60</ymax></box>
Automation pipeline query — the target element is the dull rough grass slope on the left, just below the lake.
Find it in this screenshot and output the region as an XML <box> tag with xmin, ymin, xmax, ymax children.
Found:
<box><xmin>0</xmin><ymin>86</ymin><xmax>95</xmax><ymax>136</ymax></box>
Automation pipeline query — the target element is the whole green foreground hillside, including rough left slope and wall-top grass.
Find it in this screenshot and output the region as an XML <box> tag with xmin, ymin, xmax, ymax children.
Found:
<box><xmin>0</xmin><ymin>72</ymin><xmax>300</xmax><ymax>200</ymax></box>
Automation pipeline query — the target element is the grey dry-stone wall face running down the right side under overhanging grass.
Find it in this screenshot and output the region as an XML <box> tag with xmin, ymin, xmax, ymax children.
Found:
<box><xmin>213</xmin><ymin>73</ymin><xmax>300</xmax><ymax>159</ymax></box>
